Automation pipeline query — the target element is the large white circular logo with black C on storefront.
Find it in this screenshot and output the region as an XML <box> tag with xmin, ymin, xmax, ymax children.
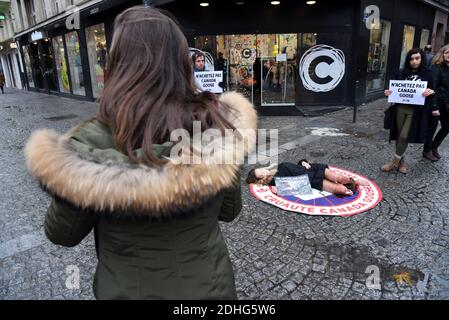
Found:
<box><xmin>299</xmin><ymin>44</ymin><xmax>345</xmax><ymax>92</ymax></box>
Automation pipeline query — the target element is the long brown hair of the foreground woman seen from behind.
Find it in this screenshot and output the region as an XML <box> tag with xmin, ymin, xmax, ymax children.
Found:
<box><xmin>96</xmin><ymin>6</ymin><xmax>235</xmax><ymax>166</ymax></box>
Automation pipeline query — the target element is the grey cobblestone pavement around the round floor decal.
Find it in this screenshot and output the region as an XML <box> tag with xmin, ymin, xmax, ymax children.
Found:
<box><xmin>0</xmin><ymin>90</ymin><xmax>449</xmax><ymax>299</ymax></box>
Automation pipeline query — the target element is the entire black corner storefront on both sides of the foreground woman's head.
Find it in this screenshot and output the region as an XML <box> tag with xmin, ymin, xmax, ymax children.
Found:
<box><xmin>14</xmin><ymin>0</ymin><xmax>447</xmax><ymax>115</ymax></box>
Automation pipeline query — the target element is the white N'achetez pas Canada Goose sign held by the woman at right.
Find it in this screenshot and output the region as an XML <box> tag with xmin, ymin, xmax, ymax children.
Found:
<box><xmin>388</xmin><ymin>80</ymin><xmax>427</xmax><ymax>106</ymax></box>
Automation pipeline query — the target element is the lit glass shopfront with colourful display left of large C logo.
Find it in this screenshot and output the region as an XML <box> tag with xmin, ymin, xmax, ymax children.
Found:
<box><xmin>195</xmin><ymin>34</ymin><xmax>298</xmax><ymax>105</ymax></box>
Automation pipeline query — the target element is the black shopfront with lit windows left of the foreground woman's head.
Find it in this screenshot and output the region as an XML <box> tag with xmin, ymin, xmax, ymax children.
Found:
<box><xmin>16</xmin><ymin>0</ymin><xmax>135</xmax><ymax>101</ymax></box>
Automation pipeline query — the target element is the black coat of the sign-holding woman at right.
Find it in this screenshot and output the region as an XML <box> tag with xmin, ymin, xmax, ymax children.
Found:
<box><xmin>388</xmin><ymin>69</ymin><xmax>438</xmax><ymax>143</ymax></box>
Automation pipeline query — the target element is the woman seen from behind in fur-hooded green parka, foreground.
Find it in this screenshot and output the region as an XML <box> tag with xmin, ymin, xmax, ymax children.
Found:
<box><xmin>25</xmin><ymin>6</ymin><xmax>257</xmax><ymax>299</ymax></box>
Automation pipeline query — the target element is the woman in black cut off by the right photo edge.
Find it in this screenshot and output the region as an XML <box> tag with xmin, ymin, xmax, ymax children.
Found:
<box><xmin>423</xmin><ymin>45</ymin><xmax>449</xmax><ymax>161</ymax></box>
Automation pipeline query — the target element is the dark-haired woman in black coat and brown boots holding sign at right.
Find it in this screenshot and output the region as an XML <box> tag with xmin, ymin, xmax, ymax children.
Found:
<box><xmin>381</xmin><ymin>48</ymin><xmax>437</xmax><ymax>174</ymax></box>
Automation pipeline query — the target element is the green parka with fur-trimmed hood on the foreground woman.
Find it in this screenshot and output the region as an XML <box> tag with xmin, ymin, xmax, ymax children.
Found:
<box><xmin>25</xmin><ymin>93</ymin><xmax>257</xmax><ymax>299</ymax></box>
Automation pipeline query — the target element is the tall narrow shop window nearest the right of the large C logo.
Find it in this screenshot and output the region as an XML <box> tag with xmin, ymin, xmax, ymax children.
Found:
<box><xmin>366</xmin><ymin>20</ymin><xmax>391</xmax><ymax>93</ymax></box>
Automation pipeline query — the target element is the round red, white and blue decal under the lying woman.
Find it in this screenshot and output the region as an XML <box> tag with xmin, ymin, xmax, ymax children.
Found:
<box><xmin>249</xmin><ymin>166</ymin><xmax>382</xmax><ymax>217</ymax></box>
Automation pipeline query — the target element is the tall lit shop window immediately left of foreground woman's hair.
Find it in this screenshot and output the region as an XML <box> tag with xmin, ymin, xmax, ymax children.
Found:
<box><xmin>86</xmin><ymin>23</ymin><xmax>107</xmax><ymax>98</ymax></box>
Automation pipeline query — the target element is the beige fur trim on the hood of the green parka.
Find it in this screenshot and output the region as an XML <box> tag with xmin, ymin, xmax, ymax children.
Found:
<box><xmin>25</xmin><ymin>92</ymin><xmax>257</xmax><ymax>216</ymax></box>
